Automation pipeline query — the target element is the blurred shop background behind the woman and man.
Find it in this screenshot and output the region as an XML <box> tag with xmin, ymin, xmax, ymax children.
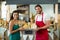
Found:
<box><xmin>0</xmin><ymin>0</ymin><xmax>60</xmax><ymax>40</ymax></box>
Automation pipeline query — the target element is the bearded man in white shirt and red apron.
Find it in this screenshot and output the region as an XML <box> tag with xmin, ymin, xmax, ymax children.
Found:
<box><xmin>35</xmin><ymin>5</ymin><xmax>50</xmax><ymax>40</ymax></box>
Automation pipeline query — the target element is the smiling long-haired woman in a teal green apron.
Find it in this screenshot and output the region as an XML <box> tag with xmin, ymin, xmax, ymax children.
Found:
<box><xmin>9</xmin><ymin>10</ymin><xmax>22</xmax><ymax>40</ymax></box>
